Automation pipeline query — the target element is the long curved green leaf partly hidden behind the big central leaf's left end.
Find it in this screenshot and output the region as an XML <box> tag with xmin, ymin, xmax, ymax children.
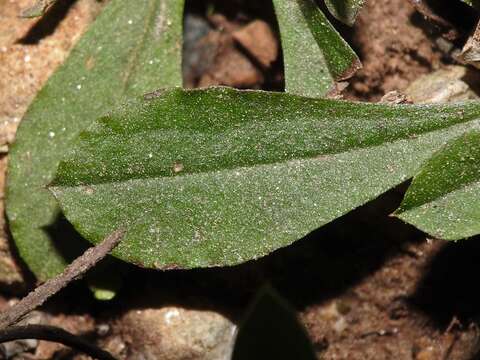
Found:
<box><xmin>7</xmin><ymin>0</ymin><xmax>183</xmax><ymax>280</ymax></box>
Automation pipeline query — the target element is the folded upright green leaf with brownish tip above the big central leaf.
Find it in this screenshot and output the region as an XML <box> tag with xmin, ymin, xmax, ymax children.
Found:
<box><xmin>273</xmin><ymin>0</ymin><xmax>361</xmax><ymax>97</ymax></box>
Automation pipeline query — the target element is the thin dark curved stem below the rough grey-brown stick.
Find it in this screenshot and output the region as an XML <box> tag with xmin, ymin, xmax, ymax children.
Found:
<box><xmin>0</xmin><ymin>325</ymin><xmax>115</xmax><ymax>360</ymax></box>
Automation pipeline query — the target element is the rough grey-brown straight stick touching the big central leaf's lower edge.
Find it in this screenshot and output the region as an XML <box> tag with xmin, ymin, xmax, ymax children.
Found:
<box><xmin>0</xmin><ymin>230</ymin><xmax>124</xmax><ymax>329</ymax></box>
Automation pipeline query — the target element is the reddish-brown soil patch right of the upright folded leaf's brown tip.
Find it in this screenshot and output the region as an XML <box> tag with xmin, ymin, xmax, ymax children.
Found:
<box><xmin>344</xmin><ymin>0</ymin><xmax>442</xmax><ymax>100</ymax></box>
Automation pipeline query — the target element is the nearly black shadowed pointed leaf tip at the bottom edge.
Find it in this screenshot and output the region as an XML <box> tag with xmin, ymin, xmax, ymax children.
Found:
<box><xmin>232</xmin><ymin>287</ymin><xmax>316</xmax><ymax>360</ymax></box>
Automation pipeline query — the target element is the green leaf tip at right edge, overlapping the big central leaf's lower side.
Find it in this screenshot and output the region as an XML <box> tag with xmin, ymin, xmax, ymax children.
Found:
<box><xmin>395</xmin><ymin>129</ymin><xmax>480</xmax><ymax>240</ymax></box>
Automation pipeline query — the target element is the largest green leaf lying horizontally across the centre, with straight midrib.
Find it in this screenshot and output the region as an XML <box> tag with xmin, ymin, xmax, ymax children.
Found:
<box><xmin>51</xmin><ymin>88</ymin><xmax>480</xmax><ymax>269</ymax></box>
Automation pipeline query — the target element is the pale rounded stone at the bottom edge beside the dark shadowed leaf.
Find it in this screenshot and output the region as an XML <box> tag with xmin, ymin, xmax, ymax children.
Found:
<box><xmin>107</xmin><ymin>306</ymin><xmax>236</xmax><ymax>360</ymax></box>
